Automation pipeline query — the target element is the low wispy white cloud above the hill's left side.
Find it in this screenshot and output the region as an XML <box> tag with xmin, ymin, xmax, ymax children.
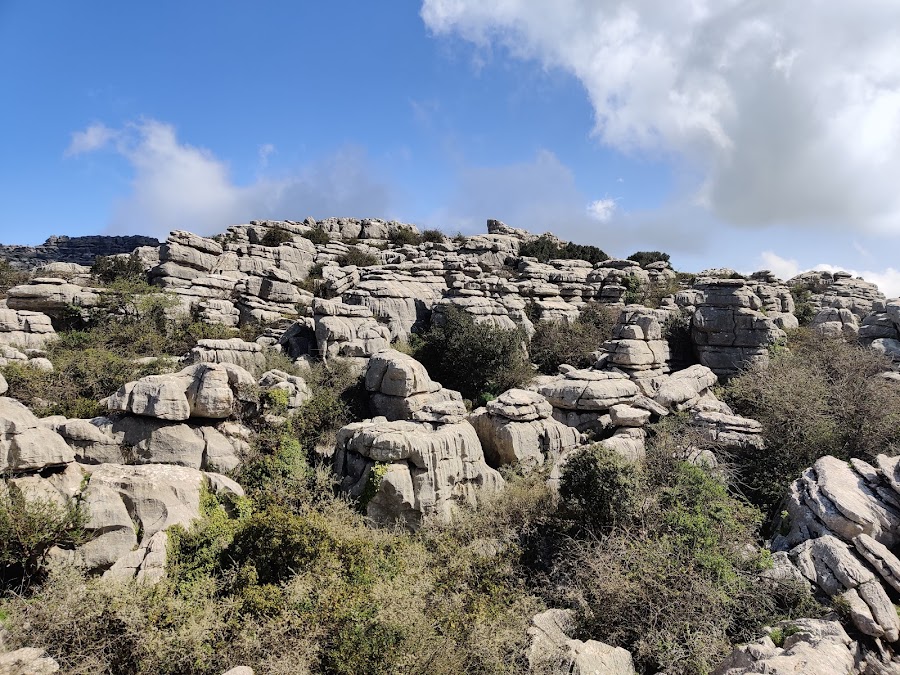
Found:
<box><xmin>70</xmin><ymin>119</ymin><xmax>390</xmax><ymax>237</ymax></box>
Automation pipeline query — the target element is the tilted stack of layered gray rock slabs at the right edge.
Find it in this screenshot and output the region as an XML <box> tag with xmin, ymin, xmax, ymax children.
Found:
<box><xmin>772</xmin><ymin>455</ymin><xmax>900</xmax><ymax>642</ymax></box>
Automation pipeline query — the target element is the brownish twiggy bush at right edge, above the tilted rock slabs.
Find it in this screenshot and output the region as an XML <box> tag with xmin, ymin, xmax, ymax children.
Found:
<box><xmin>725</xmin><ymin>330</ymin><xmax>900</xmax><ymax>509</ymax></box>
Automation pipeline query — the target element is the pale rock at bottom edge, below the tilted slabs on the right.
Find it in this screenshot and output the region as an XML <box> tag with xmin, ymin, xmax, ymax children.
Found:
<box><xmin>713</xmin><ymin>619</ymin><xmax>869</xmax><ymax>675</ymax></box>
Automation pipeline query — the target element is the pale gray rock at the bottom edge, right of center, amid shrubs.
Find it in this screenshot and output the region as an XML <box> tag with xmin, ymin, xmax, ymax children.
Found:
<box><xmin>528</xmin><ymin>609</ymin><xmax>635</xmax><ymax>675</ymax></box>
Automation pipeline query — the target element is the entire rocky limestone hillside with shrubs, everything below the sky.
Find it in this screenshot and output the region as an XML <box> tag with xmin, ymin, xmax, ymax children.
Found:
<box><xmin>0</xmin><ymin>218</ymin><xmax>900</xmax><ymax>675</ymax></box>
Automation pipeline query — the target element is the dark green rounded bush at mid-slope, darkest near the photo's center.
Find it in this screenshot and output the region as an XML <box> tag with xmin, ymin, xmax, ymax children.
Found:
<box><xmin>415</xmin><ymin>305</ymin><xmax>533</xmax><ymax>402</ymax></box>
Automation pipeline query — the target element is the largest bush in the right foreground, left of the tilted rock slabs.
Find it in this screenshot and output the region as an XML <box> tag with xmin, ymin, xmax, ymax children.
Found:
<box><xmin>553</xmin><ymin>444</ymin><xmax>815</xmax><ymax>675</ymax></box>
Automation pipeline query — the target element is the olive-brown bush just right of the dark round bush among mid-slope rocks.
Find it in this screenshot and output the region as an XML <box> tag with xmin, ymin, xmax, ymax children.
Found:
<box><xmin>528</xmin><ymin>303</ymin><xmax>619</xmax><ymax>375</ymax></box>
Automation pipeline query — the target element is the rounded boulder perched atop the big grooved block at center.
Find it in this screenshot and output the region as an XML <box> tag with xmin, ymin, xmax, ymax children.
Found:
<box><xmin>365</xmin><ymin>349</ymin><xmax>465</xmax><ymax>421</ymax></box>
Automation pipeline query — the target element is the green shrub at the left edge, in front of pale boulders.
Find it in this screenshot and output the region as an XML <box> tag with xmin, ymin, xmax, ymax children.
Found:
<box><xmin>0</xmin><ymin>482</ymin><xmax>86</xmax><ymax>590</ymax></box>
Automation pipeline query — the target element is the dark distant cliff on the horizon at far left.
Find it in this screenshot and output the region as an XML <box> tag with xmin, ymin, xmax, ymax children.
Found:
<box><xmin>0</xmin><ymin>235</ymin><xmax>159</xmax><ymax>269</ymax></box>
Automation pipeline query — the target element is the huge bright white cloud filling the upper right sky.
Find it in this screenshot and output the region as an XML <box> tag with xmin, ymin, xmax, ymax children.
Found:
<box><xmin>421</xmin><ymin>0</ymin><xmax>900</xmax><ymax>233</ymax></box>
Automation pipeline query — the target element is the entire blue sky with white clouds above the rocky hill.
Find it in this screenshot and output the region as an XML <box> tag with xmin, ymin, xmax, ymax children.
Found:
<box><xmin>0</xmin><ymin>0</ymin><xmax>900</xmax><ymax>294</ymax></box>
